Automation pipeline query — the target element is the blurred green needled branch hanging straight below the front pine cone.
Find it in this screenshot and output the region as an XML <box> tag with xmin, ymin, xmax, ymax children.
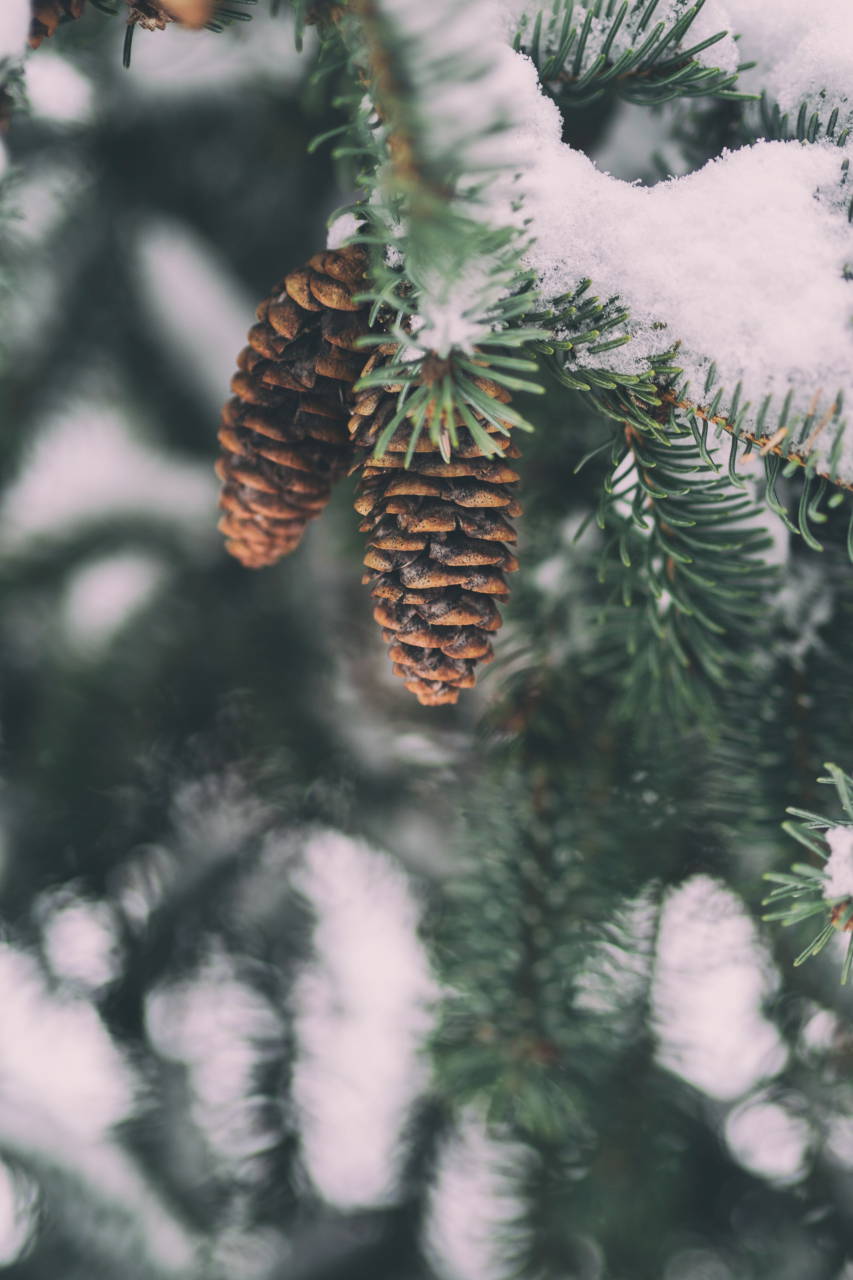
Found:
<box><xmin>433</xmin><ymin>787</ymin><xmax>602</xmax><ymax>1140</ymax></box>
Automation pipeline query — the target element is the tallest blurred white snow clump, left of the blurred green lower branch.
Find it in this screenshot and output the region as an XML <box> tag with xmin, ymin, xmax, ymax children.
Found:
<box><xmin>295</xmin><ymin>831</ymin><xmax>437</xmax><ymax>1206</ymax></box>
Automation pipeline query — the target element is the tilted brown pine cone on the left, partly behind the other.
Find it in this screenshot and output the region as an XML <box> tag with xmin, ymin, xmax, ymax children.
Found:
<box><xmin>216</xmin><ymin>246</ymin><xmax>368</xmax><ymax>568</ymax></box>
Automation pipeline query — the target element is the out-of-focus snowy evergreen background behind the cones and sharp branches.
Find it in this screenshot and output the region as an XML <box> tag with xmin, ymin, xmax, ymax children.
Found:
<box><xmin>0</xmin><ymin>12</ymin><xmax>853</xmax><ymax>1280</ymax></box>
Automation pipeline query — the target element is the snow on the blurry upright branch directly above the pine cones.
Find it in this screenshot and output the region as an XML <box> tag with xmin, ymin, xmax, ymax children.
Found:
<box><xmin>345</xmin><ymin>0</ymin><xmax>557</xmax><ymax>357</ymax></box>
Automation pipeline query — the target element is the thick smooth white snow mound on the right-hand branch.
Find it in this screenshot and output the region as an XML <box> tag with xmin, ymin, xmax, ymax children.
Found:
<box><xmin>512</xmin><ymin>133</ymin><xmax>853</xmax><ymax>483</ymax></box>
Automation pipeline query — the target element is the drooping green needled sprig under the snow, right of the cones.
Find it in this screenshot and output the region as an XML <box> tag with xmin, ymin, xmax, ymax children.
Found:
<box><xmin>592</xmin><ymin>422</ymin><xmax>771</xmax><ymax>722</ymax></box>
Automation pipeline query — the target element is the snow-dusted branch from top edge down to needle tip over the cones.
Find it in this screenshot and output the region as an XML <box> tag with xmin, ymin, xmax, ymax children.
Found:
<box><xmin>333</xmin><ymin>0</ymin><xmax>544</xmax><ymax>443</ymax></box>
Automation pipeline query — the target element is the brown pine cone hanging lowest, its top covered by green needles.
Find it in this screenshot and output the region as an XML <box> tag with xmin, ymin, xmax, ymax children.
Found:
<box><xmin>350</xmin><ymin>356</ymin><xmax>521</xmax><ymax>707</ymax></box>
